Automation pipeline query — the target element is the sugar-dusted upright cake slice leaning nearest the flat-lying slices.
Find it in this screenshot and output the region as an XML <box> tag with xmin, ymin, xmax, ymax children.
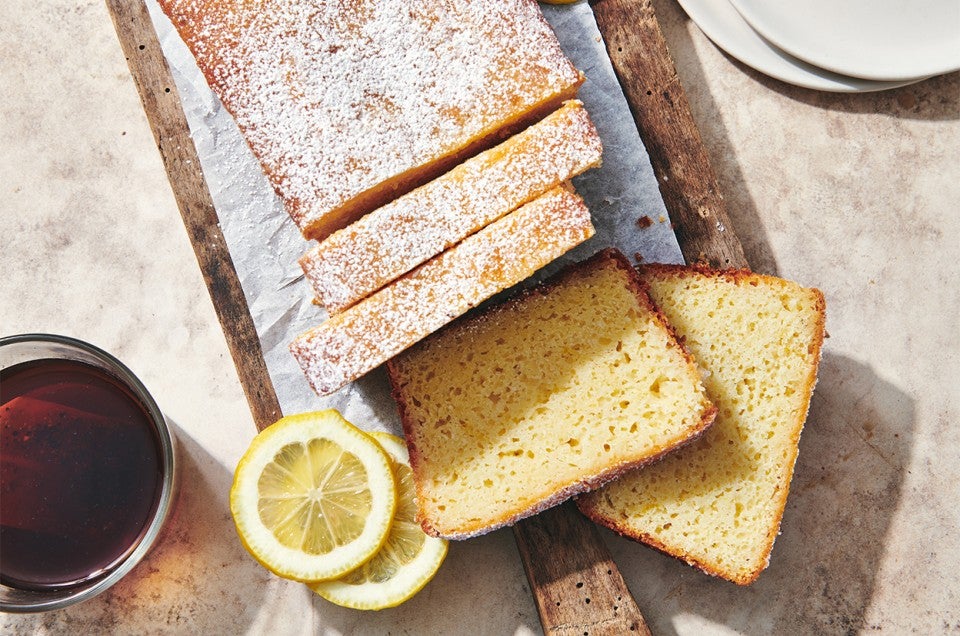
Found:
<box><xmin>290</xmin><ymin>187</ymin><xmax>594</xmax><ymax>395</ymax></box>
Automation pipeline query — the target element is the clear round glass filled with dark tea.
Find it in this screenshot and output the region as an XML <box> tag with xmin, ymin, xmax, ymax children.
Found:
<box><xmin>0</xmin><ymin>334</ymin><xmax>177</xmax><ymax>612</ymax></box>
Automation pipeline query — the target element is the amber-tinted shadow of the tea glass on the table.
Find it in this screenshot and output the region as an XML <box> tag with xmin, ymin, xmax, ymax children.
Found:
<box><xmin>9</xmin><ymin>418</ymin><xmax>270</xmax><ymax>634</ymax></box>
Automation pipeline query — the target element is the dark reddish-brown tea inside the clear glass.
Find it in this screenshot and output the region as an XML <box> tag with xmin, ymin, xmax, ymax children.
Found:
<box><xmin>0</xmin><ymin>359</ymin><xmax>163</xmax><ymax>590</ymax></box>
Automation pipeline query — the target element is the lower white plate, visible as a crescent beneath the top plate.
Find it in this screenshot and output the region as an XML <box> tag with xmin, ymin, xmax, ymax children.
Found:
<box><xmin>678</xmin><ymin>0</ymin><xmax>909</xmax><ymax>93</ymax></box>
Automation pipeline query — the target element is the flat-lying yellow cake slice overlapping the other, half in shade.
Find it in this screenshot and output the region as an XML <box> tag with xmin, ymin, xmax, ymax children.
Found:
<box><xmin>387</xmin><ymin>249</ymin><xmax>715</xmax><ymax>539</ymax></box>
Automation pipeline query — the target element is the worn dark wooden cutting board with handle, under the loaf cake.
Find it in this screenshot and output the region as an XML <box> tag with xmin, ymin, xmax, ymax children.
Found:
<box><xmin>106</xmin><ymin>0</ymin><xmax>747</xmax><ymax>636</ymax></box>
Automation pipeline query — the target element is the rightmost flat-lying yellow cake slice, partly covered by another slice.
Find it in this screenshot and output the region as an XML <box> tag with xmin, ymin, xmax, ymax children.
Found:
<box><xmin>577</xmin><ymin>266</ymin><xmax>825</xmax><ymax>585</ymax></box>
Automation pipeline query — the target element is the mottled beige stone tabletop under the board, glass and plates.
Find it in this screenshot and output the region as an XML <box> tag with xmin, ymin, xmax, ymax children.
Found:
<box><xmin>0</xmin><ymin>0</ymin><xmax>960</xmax><ymax>634</ymax></box>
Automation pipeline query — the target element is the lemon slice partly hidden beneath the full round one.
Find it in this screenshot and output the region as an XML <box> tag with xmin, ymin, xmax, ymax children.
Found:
<box><xmin>310</xmin><ymin>433</ymin><xmax>447</xmax><ymax>610</ymax></box>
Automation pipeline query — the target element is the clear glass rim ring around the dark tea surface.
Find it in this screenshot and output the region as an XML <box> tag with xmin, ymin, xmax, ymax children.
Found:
<box><xmin>0</xmin><ymin>333</ymin><xmax>177</xmax><ymax>613</ymax></box>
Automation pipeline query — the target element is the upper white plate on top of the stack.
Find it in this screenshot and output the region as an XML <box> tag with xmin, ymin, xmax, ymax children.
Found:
<box><xmin>730</xmin><ymin>0</ymin><xmax>960</xmax><ymax>81</ymax></box>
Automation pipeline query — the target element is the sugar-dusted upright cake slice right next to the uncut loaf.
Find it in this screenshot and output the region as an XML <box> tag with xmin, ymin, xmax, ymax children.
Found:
<box><xmin>300</xmin><ymin>100</ymin><xmax>602</xmax><ymax>312</ymax></box>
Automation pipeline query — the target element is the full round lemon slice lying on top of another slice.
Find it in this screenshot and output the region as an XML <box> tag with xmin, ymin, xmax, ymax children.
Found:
<box><xmin>230</xmin><ymin>410</ymin><xmax>397</xmax><ymax>581</ymax></box>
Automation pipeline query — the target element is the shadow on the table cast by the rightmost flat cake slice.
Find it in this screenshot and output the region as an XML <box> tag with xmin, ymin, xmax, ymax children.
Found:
<box><xmin>605</xmin><ymin>354</ymin><xmax>915</xmax><ymax>635</ymax></box>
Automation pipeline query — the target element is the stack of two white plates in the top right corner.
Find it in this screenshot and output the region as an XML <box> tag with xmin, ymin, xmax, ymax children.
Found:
<box><xmin>678</xmin><ymin>0</ymin><xmax>960</xmax><ymax>92</ymax></box>
